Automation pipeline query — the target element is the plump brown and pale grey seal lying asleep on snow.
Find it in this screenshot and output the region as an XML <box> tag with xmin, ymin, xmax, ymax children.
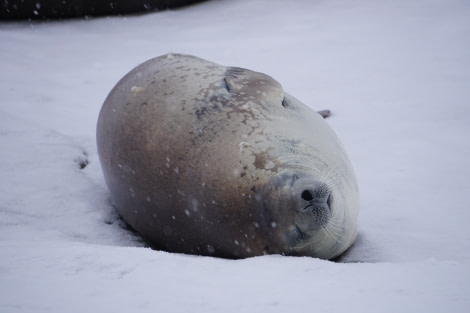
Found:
<box><xmin>97</xmin><ymin>54</ymin><xmax>359</xmax><ymax>259</ymax></box>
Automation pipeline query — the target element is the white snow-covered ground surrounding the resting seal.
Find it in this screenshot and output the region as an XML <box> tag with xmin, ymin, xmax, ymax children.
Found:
<box><xmin>0</xmin><ymin>0</ymin><xmax>470</xmax><ymax>312</ymax></box>
